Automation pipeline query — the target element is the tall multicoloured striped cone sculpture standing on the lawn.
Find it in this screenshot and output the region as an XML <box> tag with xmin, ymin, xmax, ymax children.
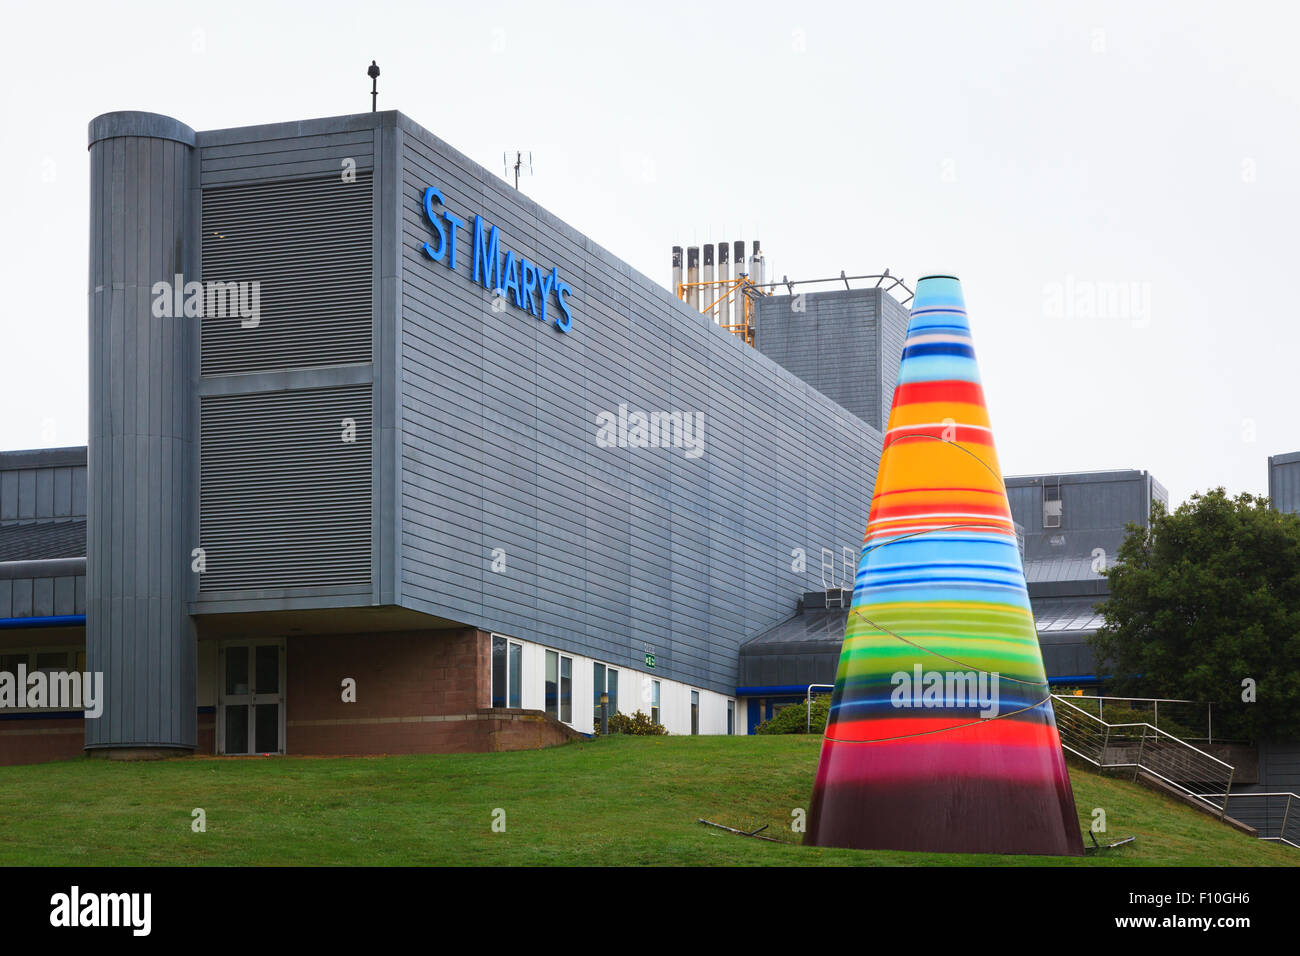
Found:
<box><xmin>807</xmin><ymin>276</ymin><xmax>1083</xmax><ymax>855</ymax></box>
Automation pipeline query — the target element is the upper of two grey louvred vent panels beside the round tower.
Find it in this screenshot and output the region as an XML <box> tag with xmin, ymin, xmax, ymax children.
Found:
<box><xmin>203</xmin><ymin>173</ymin><xmax>373</xmax><ymax>375</ymax></box>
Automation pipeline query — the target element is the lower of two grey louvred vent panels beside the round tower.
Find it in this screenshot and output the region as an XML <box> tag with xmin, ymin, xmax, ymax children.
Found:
<box><xmin>199</xmin><ymin>385</ymin><xmax>371</xmax><ymax>592</ymax></box>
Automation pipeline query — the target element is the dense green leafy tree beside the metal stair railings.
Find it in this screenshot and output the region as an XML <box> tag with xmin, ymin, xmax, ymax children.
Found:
<box><xmin>1091</xmin><ymin>488</ymin><xmax>1300</xmax><ymax>740</ymax></box>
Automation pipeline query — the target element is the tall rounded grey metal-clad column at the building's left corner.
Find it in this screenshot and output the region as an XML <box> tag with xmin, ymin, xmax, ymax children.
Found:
<box><xmin>86</xmin><ymin>113</ymin><xmax>199</xmax><ymax>748</ymax></box>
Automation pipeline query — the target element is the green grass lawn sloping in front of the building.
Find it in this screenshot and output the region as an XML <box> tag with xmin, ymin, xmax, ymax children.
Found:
<box><xmin>0</xmin><ymin>736</ymin><xmax>1300</xmax><ymax>866</ymax></box>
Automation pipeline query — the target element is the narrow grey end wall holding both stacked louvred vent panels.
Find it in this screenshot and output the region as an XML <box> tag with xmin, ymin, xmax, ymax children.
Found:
<box><xmin>199</xmin><ymin>133</ymin><xmax>378</xmax><ymax>606</ymax></box>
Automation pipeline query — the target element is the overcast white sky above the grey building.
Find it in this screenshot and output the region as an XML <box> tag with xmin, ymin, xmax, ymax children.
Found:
<box><xmin>0</xmin><ymin>0</ymin><xmax>1300</xmax><ymax>502</ymax></box>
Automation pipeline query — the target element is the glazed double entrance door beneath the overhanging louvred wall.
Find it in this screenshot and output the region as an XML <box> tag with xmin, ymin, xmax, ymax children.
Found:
<box><xmin>217</xmin><ymin>641</ymin><xmax>285</xmax><ymax>753</ymax></box>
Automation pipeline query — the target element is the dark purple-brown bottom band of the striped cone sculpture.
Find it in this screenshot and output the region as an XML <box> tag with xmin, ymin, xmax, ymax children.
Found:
<box><xmin>803</xmin><ymin>779</ymin><xmax>1083</xmax><ymax>856</ymax></box>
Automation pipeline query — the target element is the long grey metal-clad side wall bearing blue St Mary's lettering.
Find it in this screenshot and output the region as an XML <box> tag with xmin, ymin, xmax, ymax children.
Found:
<box><xmin>398</xmin><ymin>117</ymin><xmax>880</xmax><ymax>693</ymax></box>
